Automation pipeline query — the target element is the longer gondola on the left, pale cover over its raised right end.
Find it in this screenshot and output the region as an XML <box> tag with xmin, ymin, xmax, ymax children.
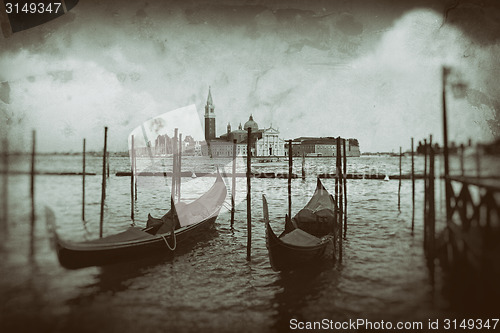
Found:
<box><xmin>46</xmin><ymin>173</ymin><xmax>227</xmax><ymax>269</ymax></box>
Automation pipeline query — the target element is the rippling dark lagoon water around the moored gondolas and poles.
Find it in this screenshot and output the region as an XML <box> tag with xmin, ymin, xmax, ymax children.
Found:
<box><xmin>0</xmin><ymin>156</ymin><xmax>496</xmax><ymax>332</ymax></box>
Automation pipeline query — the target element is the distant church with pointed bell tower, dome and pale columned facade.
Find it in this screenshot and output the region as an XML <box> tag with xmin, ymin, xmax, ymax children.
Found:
<box><xmin>202</xmin><ymin>88</ymin><xmax>285</xmax><ymax>157</ymax></box>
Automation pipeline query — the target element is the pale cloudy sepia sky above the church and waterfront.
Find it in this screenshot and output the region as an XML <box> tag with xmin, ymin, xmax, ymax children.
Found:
<box><xmin>0</xmin><ymin>0</ymin><xmax>500</xmax><ymax>152</ymax></box>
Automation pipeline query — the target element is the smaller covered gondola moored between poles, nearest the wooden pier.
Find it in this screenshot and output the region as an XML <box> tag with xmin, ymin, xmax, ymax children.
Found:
<box><xmin>262</xmin><ymin>179</ymin><xmax>338</xmax><ymax>271</ymax></box>
